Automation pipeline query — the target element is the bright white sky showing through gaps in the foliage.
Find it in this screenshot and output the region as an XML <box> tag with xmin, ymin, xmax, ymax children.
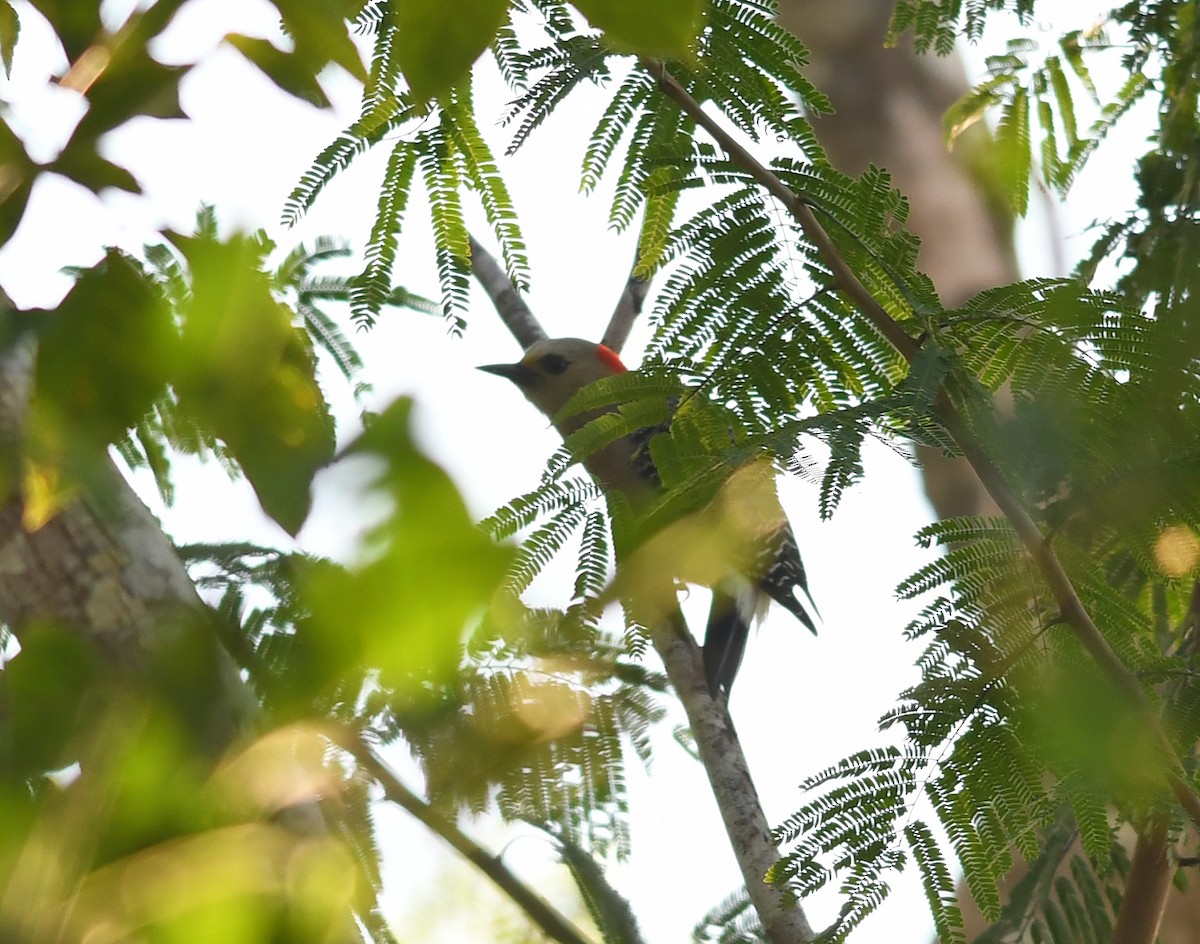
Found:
<box><xmin>0</xmin><ymin>0</ymin><xmax>1156</xmax><ymax>944</ymax></box>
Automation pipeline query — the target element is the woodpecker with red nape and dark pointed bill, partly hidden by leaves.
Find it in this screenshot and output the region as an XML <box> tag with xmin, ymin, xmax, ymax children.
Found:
<box><xmin>479</xmin><ymin>337</ymin><xmax>816</xmax><ymax>698</ymax></box>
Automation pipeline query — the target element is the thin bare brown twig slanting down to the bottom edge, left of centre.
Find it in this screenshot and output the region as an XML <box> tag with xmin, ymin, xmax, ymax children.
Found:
<box><xmin>340</xmin><ymin>732</ymin><xmax>593</xmax><ymax>944</ymax></box>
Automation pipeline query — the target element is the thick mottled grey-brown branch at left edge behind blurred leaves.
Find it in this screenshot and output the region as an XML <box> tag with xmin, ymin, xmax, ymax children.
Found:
<box><xmin>0</xmin><ymin>323</ymin><xmax>259</xmax><ymax>758</ymax></box>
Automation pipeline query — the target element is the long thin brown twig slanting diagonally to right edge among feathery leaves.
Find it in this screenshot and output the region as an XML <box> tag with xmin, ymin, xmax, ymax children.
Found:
<box><xmin>643</xmin><ymin>60</ymin><xmax>1200</xmax><ymax>824</ymax></box>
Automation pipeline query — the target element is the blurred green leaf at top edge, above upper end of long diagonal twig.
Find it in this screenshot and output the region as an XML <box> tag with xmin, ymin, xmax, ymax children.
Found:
<box><xmin>575</xmin><ymin>0</ymin><xmax>704</xmax><ymax>60</ymax></box>
